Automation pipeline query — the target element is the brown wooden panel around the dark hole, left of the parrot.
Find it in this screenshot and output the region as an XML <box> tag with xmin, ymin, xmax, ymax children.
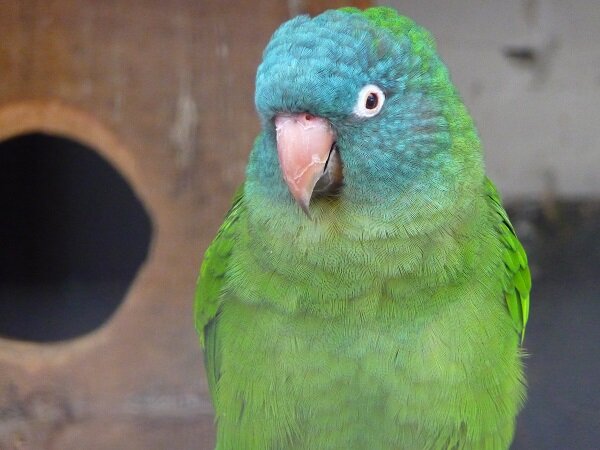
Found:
<box><xmin>0</xmin><ymin>0</ymin><xmax>367</xmax><ymax>450</ymax></box>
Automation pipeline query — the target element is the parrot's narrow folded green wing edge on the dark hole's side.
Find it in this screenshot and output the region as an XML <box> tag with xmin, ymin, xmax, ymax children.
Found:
<box><xmin>194</xmin><ymin>185</ymin><xmax>244</xmax><ymax>391</ymax></box>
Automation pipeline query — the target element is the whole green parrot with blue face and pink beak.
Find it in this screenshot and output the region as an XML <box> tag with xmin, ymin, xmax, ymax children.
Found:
<box><xmin>194</xmin><ymin>7</ymin><xmax>531</xmax><ymax>450</ymax></box>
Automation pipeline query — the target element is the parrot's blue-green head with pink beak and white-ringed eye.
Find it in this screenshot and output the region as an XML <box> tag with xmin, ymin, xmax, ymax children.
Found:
<box><xmin>250</xmin><ymin>8</ymin><xmax>481</xmax><ymax>222</ymax></box>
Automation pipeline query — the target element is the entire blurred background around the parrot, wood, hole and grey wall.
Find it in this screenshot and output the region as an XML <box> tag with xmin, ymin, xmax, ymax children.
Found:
<box><xmin>0</xmin><ymin>0</ymin><xmax>600</xmax><ymax>450</ymax></box>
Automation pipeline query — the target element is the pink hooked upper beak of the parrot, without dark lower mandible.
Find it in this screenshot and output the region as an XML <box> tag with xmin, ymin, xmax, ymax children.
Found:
<box><xmin>275</xmin><ymin>113</ymin><xmax>335</xmax><ymax>215</ymax></box>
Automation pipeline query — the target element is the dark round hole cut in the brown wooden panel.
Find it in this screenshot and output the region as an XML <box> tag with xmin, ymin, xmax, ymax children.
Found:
<box><xmin>0</xmin><ymin>133</ymin><xmax>152</xmax><ymax>342</ymax></box>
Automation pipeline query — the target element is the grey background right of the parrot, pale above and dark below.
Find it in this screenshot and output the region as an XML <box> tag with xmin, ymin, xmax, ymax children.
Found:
<box><xmin>381</xmin><ymin>0</ymin><xmax>600</xmax><ymax>450</ymax></box>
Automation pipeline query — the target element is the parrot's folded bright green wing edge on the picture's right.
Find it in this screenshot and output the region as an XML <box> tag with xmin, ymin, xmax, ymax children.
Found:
<box><xmin>485</xmin><ymin>178</ymin><xmax>531</xmax><ymax>342</ymax></box>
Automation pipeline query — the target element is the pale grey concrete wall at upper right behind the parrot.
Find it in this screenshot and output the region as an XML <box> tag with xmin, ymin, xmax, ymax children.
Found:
<box><xmin>379</xmin><ymin>0</ymin><xmax>600</xmax><ymax>199</ymax></box>
